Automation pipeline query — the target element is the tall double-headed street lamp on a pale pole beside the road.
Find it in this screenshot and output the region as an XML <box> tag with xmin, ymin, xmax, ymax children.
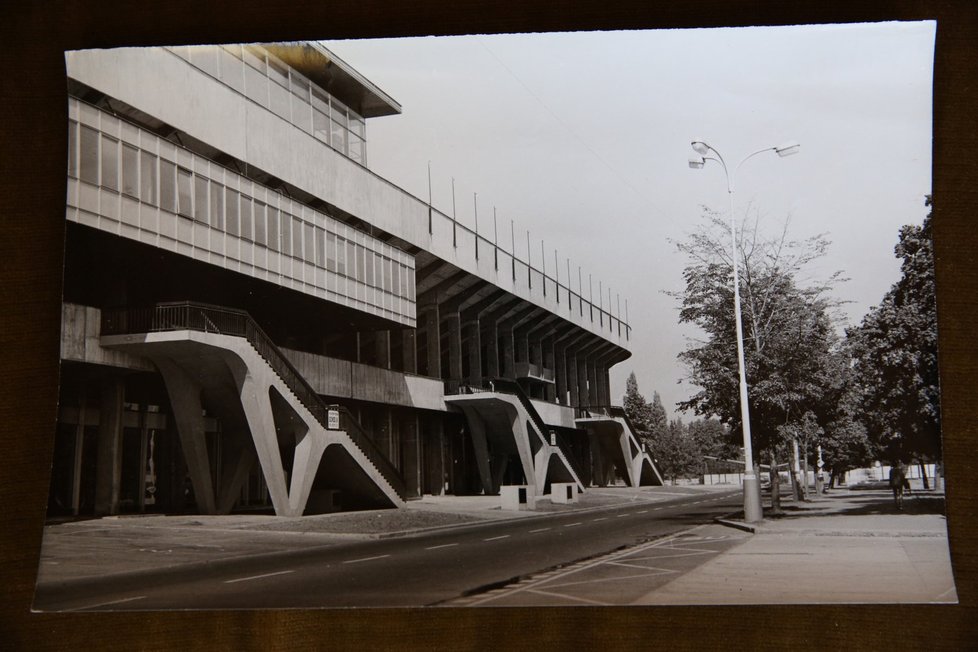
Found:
<box><xmin>689</xmin><ymin>140</ymin><xmax>801</xmax><ymax>523</ymax></box>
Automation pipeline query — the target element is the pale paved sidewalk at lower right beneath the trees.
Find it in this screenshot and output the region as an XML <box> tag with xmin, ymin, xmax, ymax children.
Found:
<box><xmin>633</xmin><ymin>489</ymin><xmax>957</xmax><ymax>605</ymax></box>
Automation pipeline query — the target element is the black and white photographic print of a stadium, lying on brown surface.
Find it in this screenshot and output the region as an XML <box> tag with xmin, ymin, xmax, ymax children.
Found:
<box><xmin>32</xmin><ymin>20</ymin><xmax>963</xmax><ymax>612</ymax></box>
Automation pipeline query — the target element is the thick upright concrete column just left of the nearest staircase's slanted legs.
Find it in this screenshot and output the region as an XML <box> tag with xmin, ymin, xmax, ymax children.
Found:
<box><xmin>95</xmin><ymin>378</ymin><xmax>125</xmax><ymax>516</ymax></box>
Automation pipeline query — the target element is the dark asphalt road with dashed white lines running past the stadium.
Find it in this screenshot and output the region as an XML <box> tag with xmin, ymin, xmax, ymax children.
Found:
<box><xmin>35</xmin><ymin>491</ymin><xmax>741</xmax><ymax>611</ymax></box>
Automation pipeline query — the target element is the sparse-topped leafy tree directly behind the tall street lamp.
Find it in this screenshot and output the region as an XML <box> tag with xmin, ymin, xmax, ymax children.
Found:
<box><xmin>675</xmin><ymin>214</ymin><xmax>843</xmax><ymax>507</ymax></box>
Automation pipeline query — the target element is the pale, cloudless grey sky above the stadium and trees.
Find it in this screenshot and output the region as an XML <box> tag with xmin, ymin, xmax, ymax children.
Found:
<box><xmin>324</xmin><ymin>22</ymin><xmax>936</xmax><ymax>419</ymax></box>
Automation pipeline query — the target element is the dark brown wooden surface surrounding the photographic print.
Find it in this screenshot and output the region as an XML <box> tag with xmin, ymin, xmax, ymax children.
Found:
<box><xmin>0</xmin><ymin>0</ymin><xmax>978</xmax><ymax>650</ymax></box>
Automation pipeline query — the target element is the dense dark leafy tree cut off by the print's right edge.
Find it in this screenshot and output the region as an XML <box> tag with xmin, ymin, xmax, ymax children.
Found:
<box><xmin>847</xmin><ymin>197</ymin><xmax>941</xmax><ymax>462</ymax></box>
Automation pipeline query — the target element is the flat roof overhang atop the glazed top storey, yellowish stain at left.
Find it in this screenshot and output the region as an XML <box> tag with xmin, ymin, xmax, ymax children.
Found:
<box><xmin>261</xmin><ymin>41</ymin><xmax>401</xmax><ymax>118</ymax></box>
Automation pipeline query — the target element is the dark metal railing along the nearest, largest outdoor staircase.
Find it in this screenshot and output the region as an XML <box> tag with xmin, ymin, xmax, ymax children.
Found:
<box><xmin>101</xmin><ymin>301</ymin><xmax>407</xmax><ymax>500</ymax></box>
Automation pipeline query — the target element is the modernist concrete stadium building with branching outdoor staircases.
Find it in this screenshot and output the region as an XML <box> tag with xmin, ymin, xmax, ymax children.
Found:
<box><xmin>49</xmin><ymin>43</ymin><xmax>661</xmax><ymax>516</ymax></box>
